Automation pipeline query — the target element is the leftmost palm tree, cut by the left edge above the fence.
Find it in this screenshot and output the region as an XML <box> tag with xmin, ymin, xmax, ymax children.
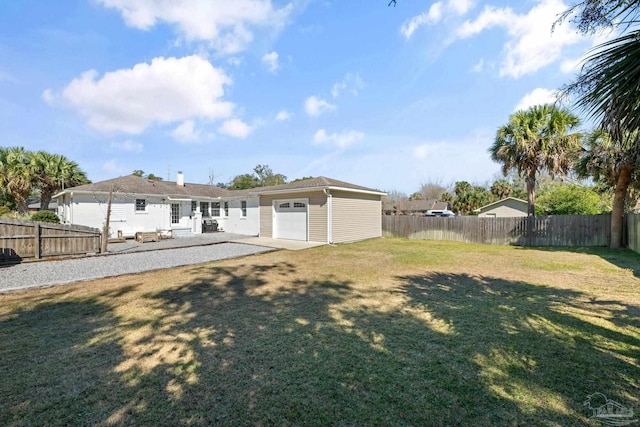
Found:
<box><xmin>0</xmin><ymin>147</ymin><xmax>35</xmax><ymax>215</ymax></box>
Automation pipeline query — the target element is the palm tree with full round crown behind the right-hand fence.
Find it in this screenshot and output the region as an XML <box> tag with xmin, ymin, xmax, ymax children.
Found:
<box><xmin>489</xmin><ymin>104</ymin><xmax>580</xmax><ymax>216</ymax></box>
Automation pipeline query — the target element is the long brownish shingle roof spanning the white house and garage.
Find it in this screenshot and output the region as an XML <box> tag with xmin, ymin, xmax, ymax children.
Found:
<box><xmin>54</xmin><ymin>175</ymin><xmax>385</xmax><ymax>198</ymax></box>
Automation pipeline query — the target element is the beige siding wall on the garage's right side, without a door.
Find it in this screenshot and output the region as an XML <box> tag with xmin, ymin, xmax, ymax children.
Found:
<box><xmin>331</xmin><ymin>191</ymin><xmax>382</xmax><ymax>243</ymax></box>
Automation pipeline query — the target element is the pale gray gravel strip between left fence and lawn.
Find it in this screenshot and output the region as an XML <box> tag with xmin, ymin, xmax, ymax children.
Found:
<box><xmin>0</xmin><ymin>243</ymin><xmax>273</xmax><ymax>292</ymax></box>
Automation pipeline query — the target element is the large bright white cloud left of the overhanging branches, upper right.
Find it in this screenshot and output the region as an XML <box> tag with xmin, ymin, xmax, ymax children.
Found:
<box><xmin>457</xmin><ymin>0</ymin><xmax>583</xmax><ymax>78</ymax></box>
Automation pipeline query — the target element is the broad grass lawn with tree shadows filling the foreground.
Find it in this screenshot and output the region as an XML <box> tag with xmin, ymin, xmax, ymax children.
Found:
<box><xmin>0</xmin><ymin>238</ymin><xmax>640</xmax><ymax>426</ymax></box>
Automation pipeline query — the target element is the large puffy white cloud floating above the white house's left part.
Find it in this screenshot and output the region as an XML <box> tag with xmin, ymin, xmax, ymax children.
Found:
<box><xmin>62</xmin><ymin>56</ymin><xmax>233</xmax><ymax>134</ymax></box>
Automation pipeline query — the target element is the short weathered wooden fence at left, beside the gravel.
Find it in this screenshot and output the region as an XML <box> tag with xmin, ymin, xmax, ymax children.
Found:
<box><xmin>0</xmin><ymin>219</ymin><xmax>101</xmax><ymax>262</ymax></box>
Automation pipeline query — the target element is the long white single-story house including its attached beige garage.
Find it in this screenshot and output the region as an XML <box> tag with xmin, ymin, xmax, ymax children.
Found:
<box><xmin>54</xmin><ymin>172</ymin><xmax>385</xmax><ymax>243</ymax></box>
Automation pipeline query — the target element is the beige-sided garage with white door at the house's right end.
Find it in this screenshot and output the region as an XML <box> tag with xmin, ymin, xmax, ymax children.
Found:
<box><xmin>252</xmin><ymin>177</ymin><xmax>385</xmax><ymax>243</ymax></box>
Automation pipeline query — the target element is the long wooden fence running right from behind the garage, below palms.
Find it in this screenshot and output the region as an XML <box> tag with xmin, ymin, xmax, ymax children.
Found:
<box><xmin>382</xmin><ymin>215</ymin><xmax>611</xmax><ymax>246</ymax></box>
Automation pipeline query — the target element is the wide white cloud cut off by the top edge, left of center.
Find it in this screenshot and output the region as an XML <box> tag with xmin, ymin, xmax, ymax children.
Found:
<box><xmin>97</xmin><ymin>0</ymin><xmax>293</xmax><ymax>54</ymax></box>
